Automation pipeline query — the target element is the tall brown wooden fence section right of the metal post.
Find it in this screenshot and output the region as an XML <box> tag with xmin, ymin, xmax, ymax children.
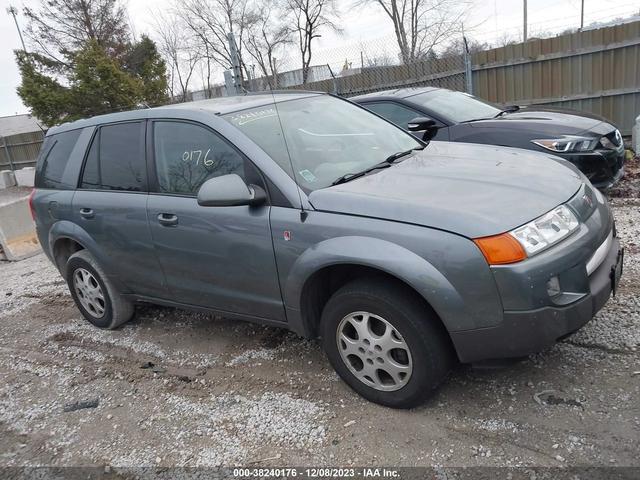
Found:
<box><xmin>472</xmin><ymin>21</ymin><xmax>640</xmax><ymax>135</ymax></box>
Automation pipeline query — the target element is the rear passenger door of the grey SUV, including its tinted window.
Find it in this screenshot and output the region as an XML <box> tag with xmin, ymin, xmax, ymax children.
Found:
<box><xmin>73</xmin><ymin>121</ymin><xmax>165</xmax><ymax>297</ymax></box>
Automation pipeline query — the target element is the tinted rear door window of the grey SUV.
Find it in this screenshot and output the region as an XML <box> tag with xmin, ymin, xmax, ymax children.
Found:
<box><xmin>80</xmin><ymin>122</ymin><xmax>146</xmax><ymax>192</ymax></box>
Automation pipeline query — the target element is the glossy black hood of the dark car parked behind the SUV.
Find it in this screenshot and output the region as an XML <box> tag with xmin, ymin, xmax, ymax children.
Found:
<box><xmin>469</xmin><ymin>107</ymin><xmax>615</xmax><ymax>137</ymax></box>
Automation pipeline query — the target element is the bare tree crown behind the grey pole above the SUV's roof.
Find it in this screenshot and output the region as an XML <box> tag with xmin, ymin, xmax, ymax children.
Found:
<box><xmin>174</xmin><ymin>0</ymin><xmax>255</xmax><ymax>84</ymax></box>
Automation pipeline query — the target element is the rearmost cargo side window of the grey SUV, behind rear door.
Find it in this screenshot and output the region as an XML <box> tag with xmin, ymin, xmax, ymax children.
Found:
<box><xmin>36</xmin><ymin>130</ymin><xmax>82</xmax><ymax>190</ymax></box>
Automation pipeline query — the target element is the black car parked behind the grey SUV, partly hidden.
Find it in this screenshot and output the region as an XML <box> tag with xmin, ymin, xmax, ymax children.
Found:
<box><xmin>351</xmin><ymin>87</ymin><xmax>624</xmax><ymax>189</ymax></box>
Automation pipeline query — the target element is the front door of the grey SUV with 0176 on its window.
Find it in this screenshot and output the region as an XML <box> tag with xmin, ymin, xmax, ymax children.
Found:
<box><xmin>148</xmin><ymin>120</ymin><xmax>284</xmax><ymax>321</ymax></box>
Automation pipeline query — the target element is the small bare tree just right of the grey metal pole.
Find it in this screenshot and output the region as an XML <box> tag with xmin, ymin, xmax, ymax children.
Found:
<box><xmin>244</xmin><ymin>1</ymin><xmax>293</xmax><ymax>88</ymax></box>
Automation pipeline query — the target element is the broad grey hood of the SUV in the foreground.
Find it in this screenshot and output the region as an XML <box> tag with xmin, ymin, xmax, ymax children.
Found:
<box><xmin>309</xmin><ymin>142</ymin><xmax>583</xmax><ymax>238</ymax></box>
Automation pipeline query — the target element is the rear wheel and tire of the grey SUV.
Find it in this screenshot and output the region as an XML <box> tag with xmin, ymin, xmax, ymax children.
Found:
<box><xmin>65</xmin><ymin>250</ymin><xmax>134</xmax><ymax>330</ymax></box>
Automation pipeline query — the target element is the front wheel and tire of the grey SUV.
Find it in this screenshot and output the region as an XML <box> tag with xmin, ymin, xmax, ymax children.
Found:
<box><xmin>321</xmin><ymin>279</ymin><xmax>455</xmax><ymax>408</ymax></box>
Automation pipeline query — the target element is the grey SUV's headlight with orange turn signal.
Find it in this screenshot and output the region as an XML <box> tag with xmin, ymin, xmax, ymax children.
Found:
<box><xmin>473</xmin><ymin>205</ymin><xmax>579</xmax><ymax>265</ymax></box>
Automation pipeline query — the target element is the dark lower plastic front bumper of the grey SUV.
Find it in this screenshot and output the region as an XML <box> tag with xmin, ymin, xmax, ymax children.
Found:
<box><xmin>451</xmin><ymin>238</ymin><xmax>622</xmax><ymax>363</ymax></box>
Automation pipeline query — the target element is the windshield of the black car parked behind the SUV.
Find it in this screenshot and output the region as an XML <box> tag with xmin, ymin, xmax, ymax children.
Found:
<box><xmin>409</xmin><ymin>90</ymin><xmax>500</xmax><ymax>123</ymax></box>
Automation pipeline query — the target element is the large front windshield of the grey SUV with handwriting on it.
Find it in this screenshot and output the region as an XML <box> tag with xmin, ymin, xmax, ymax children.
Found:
<box><xmin>223</xmin><ymin>95</ymin><xmax>422</xmax><ymax>191</ymax></box>
